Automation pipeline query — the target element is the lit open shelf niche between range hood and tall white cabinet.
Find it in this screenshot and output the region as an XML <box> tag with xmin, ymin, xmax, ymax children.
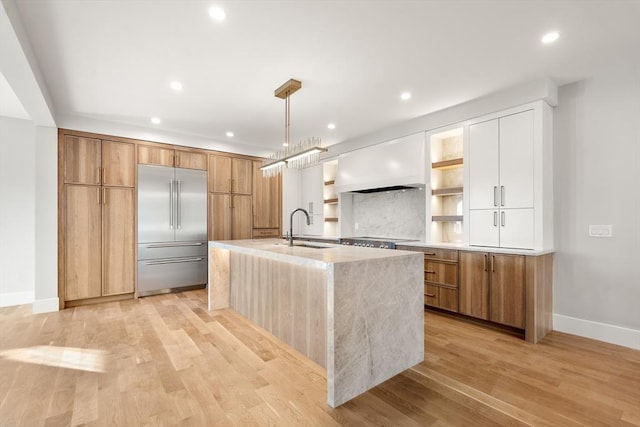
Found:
<box><xmin>428</xmin><ymin>127</ymin><xmax>464</xmax><ymax>243</ymax></box>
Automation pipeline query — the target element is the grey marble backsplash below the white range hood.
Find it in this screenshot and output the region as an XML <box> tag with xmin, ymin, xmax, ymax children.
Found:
<box><xmin>353</xmin><ymin>188</ymin><xmax>426</xmax><ymax>240</ymax></box>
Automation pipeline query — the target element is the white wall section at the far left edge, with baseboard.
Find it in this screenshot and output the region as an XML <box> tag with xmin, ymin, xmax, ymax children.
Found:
<box><xmin>0</xmin><ymin>117</ymin><xmax>36</xmax><ymax>306</ymax></box>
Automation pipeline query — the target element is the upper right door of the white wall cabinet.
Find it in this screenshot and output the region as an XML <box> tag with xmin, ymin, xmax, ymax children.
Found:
<box><xmin>500</xmin><ymin>110</ymin><xmax>533</xmax><ymax>208</ymax></box>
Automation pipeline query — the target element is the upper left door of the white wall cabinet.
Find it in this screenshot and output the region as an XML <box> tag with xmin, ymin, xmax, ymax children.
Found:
<box><xmin>465</xmin><ymin>120</ymin><xmax>499</xmax><ymax>209</ymax></box>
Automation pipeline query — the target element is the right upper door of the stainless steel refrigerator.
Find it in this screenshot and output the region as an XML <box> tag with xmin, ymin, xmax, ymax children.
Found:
<box><xmin>174</xmin><ymin>168</ymin><xmax>207</xmax><ymax>242</ymax></box>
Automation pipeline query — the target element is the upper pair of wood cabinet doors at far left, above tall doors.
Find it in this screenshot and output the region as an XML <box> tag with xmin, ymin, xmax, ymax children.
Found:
<box><xmin>63</xmin><ymin>135</ymin><xmax>136</xmax><ymax>187</ymax></box>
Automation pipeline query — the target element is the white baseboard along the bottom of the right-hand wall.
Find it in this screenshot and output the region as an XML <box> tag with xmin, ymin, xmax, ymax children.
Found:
<box><xmin>553</xmin><ymin>314</ymin><xmax>640</xmax><ymax>350</ymax></box>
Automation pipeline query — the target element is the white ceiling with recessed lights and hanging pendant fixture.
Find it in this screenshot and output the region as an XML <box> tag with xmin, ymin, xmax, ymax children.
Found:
<box><xmin>10</xmin><ymin>0</ymin><xmax>640</xmax><ymax>154</ymax></box>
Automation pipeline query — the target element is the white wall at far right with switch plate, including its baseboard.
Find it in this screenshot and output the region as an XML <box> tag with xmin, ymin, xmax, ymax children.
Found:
<box><xmin>554</xmin><ymin>64</ymin><xmax>640</xmax><ymax>348</ymax></box>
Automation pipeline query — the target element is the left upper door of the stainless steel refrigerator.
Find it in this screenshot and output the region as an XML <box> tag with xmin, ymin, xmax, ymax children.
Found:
<box><xmin>138</xmin><ymin>165</ymin><xmax>176</xmax><ymax>243</ymax></box>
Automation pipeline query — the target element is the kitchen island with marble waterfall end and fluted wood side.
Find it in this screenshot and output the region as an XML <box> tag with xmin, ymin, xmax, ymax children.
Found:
<box><xmin>208</xmin><ymin>239</ymin><xmax>424</xmax><ymax>407</ymax></box>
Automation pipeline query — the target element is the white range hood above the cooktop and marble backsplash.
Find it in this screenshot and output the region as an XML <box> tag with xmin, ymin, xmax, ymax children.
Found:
<box><xmin>335</xmin><ymin>132</ymin><xmax>427</xmax><ymax>193</ymax></box>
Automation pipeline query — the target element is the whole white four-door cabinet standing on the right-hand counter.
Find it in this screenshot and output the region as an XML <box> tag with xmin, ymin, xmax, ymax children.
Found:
<box><xmin>467</xmin><ymin>101</ymin><xmax>553</xmax><ymax>250</ymax></box>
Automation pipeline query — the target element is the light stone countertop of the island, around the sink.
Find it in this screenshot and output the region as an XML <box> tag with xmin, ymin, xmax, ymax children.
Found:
<box><xmin>209</xmin><ymin>239</ymin><xmax>415</xmax><ymax>268</ymax></box>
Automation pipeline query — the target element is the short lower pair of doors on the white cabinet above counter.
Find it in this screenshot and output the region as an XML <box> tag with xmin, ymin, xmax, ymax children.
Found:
<box><xmin>469</xmin><ymin>209</ymin><xmax>534</xmax><ymax>249</ymax></box>
